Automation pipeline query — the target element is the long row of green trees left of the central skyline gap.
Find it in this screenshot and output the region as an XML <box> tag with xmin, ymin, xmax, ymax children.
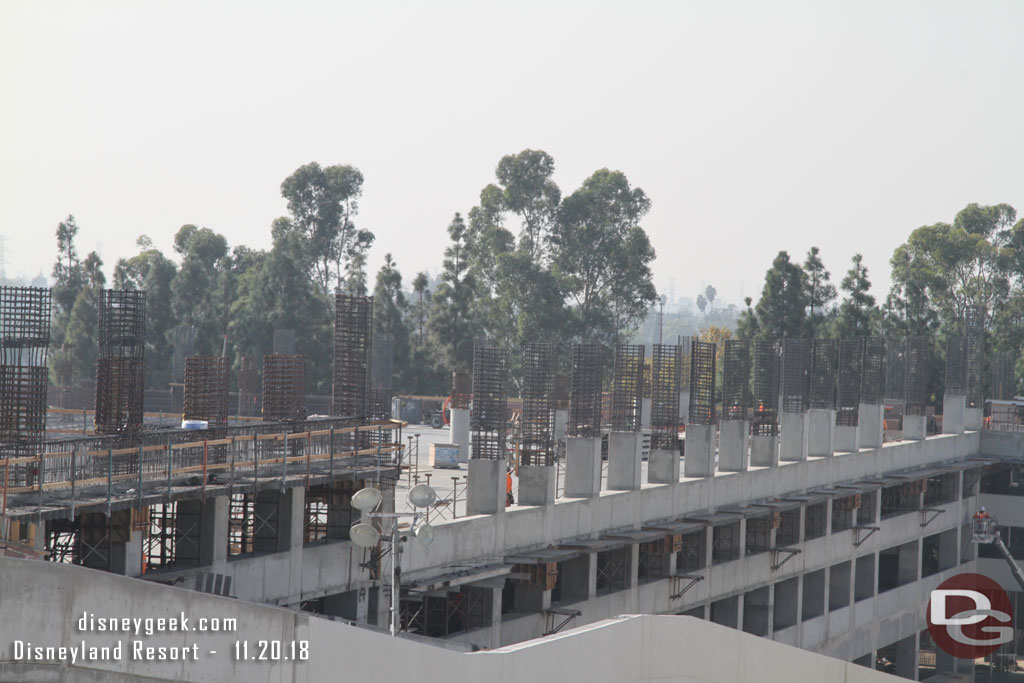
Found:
<box><xmin>51</xmin><ymin>150</ymin><xmax>657</xmax><ymax>394</ymax></box>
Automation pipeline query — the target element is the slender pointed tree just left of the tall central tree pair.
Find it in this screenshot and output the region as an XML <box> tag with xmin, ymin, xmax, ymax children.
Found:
<box><xmin>430</xmin><ymin>213</ymin><xmax>475</xmax><ymax>370</ymax></box>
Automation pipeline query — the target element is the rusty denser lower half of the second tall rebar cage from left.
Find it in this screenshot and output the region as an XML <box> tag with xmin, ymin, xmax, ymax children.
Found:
<box><xmin>95</xmin><ymin>356</ymin><xmax>145</xmax><ymax>434</ymax></box>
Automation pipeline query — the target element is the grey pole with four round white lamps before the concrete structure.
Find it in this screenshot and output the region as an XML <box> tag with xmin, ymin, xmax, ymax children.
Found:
<box><xmin>348</xmin><ymin>483</ymin><xmax>437</xmax><ymax>636</ymax></box>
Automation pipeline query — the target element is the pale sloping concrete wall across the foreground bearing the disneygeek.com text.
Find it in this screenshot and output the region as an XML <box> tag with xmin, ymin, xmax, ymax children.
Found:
<box><xmin>0</xmin><ymin>557</ymin><xmax>892</xmax><ymax>683</ymax></box>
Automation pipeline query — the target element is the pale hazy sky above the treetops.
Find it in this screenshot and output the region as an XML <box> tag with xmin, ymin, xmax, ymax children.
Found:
<box><xmin>0</xmin><ymin>0</ymin><xmax>1024</xmax><ymax>303</ymax></box>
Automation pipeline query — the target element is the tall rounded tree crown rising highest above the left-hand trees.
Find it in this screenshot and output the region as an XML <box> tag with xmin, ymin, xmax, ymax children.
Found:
<box><xmin>281</xmin><ymin>162</ymin><xmax>374</xmax><ymax>294</ymax></box>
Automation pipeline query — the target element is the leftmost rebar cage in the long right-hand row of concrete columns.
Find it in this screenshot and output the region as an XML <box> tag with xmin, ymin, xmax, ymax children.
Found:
<box><xmin>470</xmin><ymin>346</ymin><xmax>509</xmax><ymax>460</ymax></box>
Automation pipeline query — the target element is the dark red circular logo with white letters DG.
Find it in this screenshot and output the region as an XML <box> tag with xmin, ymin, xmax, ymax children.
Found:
<box><xmin>928</xmin><ymin>573</ymin><xmax>1014</xmax><ymax>659</ymax></box>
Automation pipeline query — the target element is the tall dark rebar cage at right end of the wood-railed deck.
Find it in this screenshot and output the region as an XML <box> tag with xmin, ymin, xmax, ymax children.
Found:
<box><xmin>331</xmin><ymin>294</ymin><xmax>374</xmax><ymax>419</ymax></box>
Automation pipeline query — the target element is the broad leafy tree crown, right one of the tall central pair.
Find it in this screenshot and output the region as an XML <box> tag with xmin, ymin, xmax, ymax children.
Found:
<box><xmin>551</xmin><ymin>169</ymin><xmax>657</xmax><ymax>342</ymax></box>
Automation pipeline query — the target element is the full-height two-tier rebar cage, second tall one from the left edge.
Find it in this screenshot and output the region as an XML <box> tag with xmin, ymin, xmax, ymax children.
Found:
<box><xmin>95</xmin><ymin>290</ymin><xmax>145</xmax><ymax>434</ymax></box>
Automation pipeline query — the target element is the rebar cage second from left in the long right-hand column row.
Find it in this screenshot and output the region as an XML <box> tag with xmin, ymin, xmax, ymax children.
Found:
<box><xmin>522</xmin><ymin>342</ymin><xmax>555</xmax><ymax>466</ymax></box>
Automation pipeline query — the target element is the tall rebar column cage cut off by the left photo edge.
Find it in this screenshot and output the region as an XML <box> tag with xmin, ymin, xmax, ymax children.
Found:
<box><xmin>0</xmin><ymin>287</ymin><xmax>50</xmax><ymax>489</ymax></box>
